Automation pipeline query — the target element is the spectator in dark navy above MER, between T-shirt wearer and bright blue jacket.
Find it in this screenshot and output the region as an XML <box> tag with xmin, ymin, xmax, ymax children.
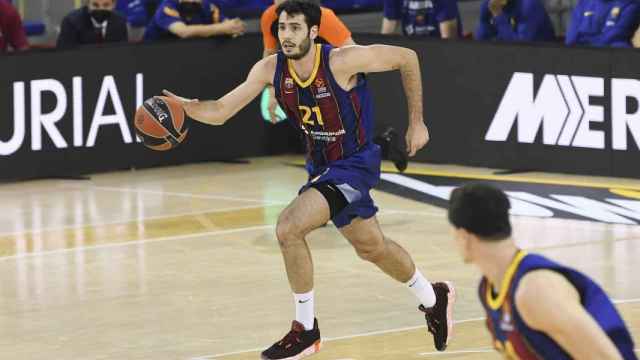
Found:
<box><xmin>475</xmin><ymin>0</ymin><xmax>555</xmax><ymax>41</ymax></box>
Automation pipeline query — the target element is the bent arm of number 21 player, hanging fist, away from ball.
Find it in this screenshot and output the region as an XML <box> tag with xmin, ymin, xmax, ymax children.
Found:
<box><xmin>330</xmin><ymin>45</ymin><xmax>429</xmax><ymax>156</ymax></box>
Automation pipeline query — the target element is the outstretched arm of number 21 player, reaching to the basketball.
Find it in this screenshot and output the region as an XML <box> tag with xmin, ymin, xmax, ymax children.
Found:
<box><xmin>163</xmin><ymin>56</ymin><xmax>276</xmax><ymax>125</ymax></box>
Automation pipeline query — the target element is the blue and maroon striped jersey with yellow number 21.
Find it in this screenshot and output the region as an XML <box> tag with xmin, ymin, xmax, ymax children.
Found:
<box><xmin>273</xmin><ymin>44</ymin><xmax>373</xmax><ymax>169</ymax></box>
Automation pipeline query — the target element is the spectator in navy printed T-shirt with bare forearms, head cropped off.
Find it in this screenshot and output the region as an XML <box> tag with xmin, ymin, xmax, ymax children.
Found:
<box><xmin>381</xmin><ymin>0</ymin><xmax>462</xmax><ymax>39</ymax></box>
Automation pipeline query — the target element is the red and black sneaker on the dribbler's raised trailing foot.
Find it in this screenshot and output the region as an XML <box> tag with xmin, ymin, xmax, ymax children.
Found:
<box><xmin>418</xmin><ymin>281</ymin><xmax>456</xmax><ymax>351</ymax></box>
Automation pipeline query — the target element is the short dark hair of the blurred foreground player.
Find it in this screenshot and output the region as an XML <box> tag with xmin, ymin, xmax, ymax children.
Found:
<box><xmin>449</xmin><ymin>184</ymin><xmax>511</xmax><ymax>241</ymax></box>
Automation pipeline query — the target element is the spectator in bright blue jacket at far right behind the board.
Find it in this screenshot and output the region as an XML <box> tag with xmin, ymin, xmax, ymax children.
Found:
<box><xmin>565</xmin><ymin>0</ymin><xmax>640</xmax><ymax>47</ymax></box>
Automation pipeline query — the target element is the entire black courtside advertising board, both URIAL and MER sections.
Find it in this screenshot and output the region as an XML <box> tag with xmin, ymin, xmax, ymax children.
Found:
<box><xmin>0</xmin><ymin>35</ymin><xmax>640</xmax><ymax>179</ymax></box>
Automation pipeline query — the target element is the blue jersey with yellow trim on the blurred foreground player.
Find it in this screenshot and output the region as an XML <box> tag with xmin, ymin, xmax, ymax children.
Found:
<box><xmin>478</xmin><ymin>250</ymin><xmax>637</xmax><ymax>360</ymax></box>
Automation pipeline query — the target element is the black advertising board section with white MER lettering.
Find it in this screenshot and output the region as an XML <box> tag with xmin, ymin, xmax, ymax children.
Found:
<box><xmin>356</xmin><ymin>36</ymin><xmax>640</xmax><ymax>177</ymax></box>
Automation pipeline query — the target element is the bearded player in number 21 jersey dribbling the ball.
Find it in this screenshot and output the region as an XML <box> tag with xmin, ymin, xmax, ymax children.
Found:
<box><xmin>165</xmin><ymin>0</ymin><xmax>455</xmax><ymax>359</ymax></box>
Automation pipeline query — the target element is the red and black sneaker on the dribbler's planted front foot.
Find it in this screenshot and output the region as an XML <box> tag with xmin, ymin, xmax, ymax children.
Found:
<box><xmin>261</xmin><ymin>319</ymin><xmax>322</xmax><ymax>360</ymax></box>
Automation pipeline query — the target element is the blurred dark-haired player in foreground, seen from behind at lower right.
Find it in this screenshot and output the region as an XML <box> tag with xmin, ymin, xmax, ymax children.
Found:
<box><xmin>449</xmin><ymin>184</ymin><xmax>636</xmax><ymax>359</ymax></box>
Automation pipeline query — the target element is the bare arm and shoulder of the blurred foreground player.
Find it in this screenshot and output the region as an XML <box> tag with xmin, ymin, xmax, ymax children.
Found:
<box><xmin>515</xmin><ymin>270</ymin><xmax>622</xmax><ymax>359</ymax></box>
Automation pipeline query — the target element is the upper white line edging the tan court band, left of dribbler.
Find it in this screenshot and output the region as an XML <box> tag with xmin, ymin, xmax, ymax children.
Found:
<box><xmin>0</xmin><ymin>202</ymin><xmax>288</xmax><ymax>236</ymax></box>
